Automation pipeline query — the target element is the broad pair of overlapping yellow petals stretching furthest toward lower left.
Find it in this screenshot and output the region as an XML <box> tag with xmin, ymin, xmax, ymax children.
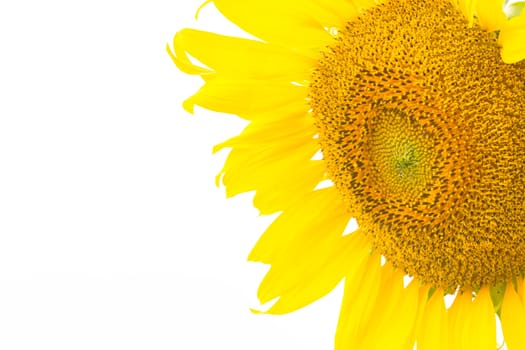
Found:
<box><xmin>248</xmin><ymin>188</ymin><xmax>354</xmax><ymax>314</ymax></box>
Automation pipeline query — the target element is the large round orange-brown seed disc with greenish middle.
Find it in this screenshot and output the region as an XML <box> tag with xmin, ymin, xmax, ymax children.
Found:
<box><xmin>310</xmin><ymin>0</ymin><xmax>525</xmax><ymax>288</ymax></box>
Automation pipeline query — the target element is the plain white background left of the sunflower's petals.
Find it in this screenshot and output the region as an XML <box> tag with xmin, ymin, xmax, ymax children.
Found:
<box><xmin>0</xmin><ymin>0</ymin><xmax>341</xmax><ymax>350</ymax></box>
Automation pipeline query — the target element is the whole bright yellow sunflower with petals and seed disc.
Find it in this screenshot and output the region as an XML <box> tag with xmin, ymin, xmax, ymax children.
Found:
<box><xmin>168</xmin><ymin>0</ymin><xmax>525</xmax><ymax>350</ymax></box>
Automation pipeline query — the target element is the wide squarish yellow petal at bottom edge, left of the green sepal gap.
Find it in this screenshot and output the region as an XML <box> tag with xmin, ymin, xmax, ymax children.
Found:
<box><xmin>449</xmin><ymin>286</ymin><xmax>497</xmax><ymax>350</ymax></box>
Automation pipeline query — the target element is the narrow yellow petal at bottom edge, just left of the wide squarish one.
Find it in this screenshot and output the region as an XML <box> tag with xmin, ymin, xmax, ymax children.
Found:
<box><xmin>417</xmin><ymin>290</ymin><xmax>448</xmax><ymax>350</ymax></box>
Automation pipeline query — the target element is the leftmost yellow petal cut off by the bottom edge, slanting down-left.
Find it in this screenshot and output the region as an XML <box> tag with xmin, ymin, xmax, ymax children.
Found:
<box><xmin>335</xmin><ymin>253</ymin><xmax>382</xmax><ymax>350</ymax></box>
